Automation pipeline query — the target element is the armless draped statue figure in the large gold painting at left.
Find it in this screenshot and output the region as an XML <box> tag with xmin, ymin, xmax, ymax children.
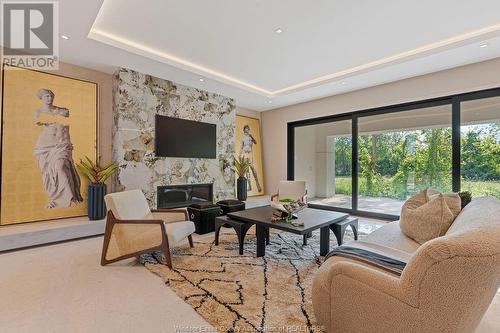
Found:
<box><xmin>33</xmin><ymin>89</ymin><xmax>83</xmax><ymax>208</ymax></box>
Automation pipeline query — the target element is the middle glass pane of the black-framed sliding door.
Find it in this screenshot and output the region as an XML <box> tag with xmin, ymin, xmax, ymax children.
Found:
<box><xmin>358</xmin><ymin>105</ymin><xmax>452</xmax><ymax>215</ymax></box>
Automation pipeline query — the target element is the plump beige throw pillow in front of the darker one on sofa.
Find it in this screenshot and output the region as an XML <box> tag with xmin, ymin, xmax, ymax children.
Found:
<box><xmin>399</xmin><ymin>189</ymin><xmax>461</xmax><ymax>244</ymax></box>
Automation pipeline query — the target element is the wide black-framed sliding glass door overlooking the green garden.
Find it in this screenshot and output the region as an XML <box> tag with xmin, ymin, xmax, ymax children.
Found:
<box><xmin>288</xmin><ymin>88</ymin><xmax>500</xmax><ymax>219</ymax></box>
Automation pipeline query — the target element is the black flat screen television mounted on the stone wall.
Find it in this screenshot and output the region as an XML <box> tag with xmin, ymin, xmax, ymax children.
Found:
<box><xmin>155</xmin><ymin>115</ymin><xmax>217</xmax><ymax>158</ymax></box>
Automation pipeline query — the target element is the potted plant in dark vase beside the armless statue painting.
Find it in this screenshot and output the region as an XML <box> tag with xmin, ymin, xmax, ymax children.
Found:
<box><xmin>76</xmin><ymin>156</ymin><xmax>118</xmax><ymax>220</ymax></box>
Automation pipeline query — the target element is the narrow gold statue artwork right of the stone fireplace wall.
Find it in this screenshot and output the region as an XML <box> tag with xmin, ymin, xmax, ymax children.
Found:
<box><xmin>235</xmin><ymin>115</ymin><xmax>264</xmax><ymax>196</ymax></box>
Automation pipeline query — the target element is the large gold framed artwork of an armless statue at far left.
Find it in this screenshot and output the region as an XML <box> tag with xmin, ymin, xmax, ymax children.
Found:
<box><xmin>0</xmin><ymin>65</ymin><xmax>97</xmax><ymax>225</ymax></box>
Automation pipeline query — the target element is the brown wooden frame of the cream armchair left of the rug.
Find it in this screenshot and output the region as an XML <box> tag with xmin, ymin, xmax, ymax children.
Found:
<box><xmin>101</xmin><ymin>209</ymin><xmax>193</xmax><ymax>268</ymax></box>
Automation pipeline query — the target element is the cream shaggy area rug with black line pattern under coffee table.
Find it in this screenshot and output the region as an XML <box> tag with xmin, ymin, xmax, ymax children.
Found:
<box><xmin>141</xmin><ymin>224</ymin><xmax>374</xmax><ymax>332</ymax></box>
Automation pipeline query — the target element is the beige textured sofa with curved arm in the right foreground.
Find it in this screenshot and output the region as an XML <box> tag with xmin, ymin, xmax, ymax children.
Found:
<box><xmin>312</xmin><ymin>197</ymin><xmax>500</xmax><ymax>333</ymax></box>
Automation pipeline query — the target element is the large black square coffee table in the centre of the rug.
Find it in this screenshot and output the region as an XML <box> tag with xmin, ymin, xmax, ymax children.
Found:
<box><xmin>227</xmin><ymin>206</ymin><xmax>349</xmax><ymax>257</ymax></box>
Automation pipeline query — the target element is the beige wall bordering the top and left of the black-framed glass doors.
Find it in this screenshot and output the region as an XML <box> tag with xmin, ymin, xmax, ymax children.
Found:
<box><xmin>261</xmin><ymin>58</ymin><xmax>500</xmax><ymax>189</ymax></box>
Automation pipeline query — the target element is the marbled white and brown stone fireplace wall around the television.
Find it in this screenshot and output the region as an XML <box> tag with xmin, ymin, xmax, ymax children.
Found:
<box><xmin>113</xmin><ymin>68</ymin><xmax>236</xmax><ymax>208</ymax></box>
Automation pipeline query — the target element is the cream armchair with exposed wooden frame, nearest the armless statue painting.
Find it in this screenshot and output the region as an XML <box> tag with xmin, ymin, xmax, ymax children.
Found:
<box><xmin>101</xmin><ymin>190</ymin><xmax>195</xmax><ymax>268</ymax></box>
